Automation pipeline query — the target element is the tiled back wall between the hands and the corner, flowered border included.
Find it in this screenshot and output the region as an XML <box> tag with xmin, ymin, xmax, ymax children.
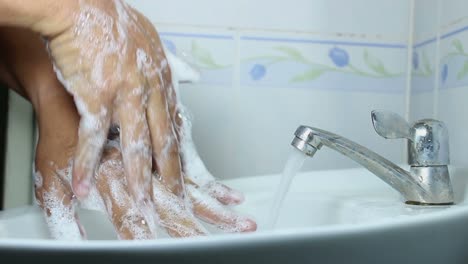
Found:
<box><xmin>129</xmin><ymin>0</ymin><xmax>410</xmax><ymax>178</ymax></box>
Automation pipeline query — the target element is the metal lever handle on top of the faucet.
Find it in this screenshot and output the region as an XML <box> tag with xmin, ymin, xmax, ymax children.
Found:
<box><xmin>371</xmin><ymin>110</ymin><xmax>411</xmax><ymax>139</ymax></box>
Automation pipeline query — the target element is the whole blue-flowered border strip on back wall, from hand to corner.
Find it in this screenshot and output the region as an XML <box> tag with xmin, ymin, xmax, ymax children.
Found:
<box><xmin>160</xmin><ymin>28</ymin><xmax>407</xmax><ymax>93</ymax></box>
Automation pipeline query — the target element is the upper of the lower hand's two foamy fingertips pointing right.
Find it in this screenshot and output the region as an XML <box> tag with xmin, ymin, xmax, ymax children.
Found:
<box><xmin>201</xmin><ymin>181</ymin><xmax>244</xmax><ymax>205</ymax></box>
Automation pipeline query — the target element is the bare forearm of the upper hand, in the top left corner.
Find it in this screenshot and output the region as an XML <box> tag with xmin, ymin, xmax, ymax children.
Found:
<box><xmin>0</xmin><ymin>0</ymin><xmax>78</xmax><ymax>35</ymax></box>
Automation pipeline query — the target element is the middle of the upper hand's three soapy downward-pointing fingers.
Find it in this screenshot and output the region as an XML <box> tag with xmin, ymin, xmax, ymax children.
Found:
<box><xmin>118</xmin><ymin>89</ymin><xmax>152</xmax><ymax>203</ymax></box>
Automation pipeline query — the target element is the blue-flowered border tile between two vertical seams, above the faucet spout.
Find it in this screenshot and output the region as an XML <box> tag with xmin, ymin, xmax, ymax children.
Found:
<box><xmin>240</xmin><ymin>34</ymin><xmax>406</xmax><ymax>92</ymax></box>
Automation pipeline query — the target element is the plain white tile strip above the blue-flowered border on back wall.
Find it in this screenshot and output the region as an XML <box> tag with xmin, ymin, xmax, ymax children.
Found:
<box><xmin>128</xmin><ymin>0</ymin><xmax>409</xmax><ymax>39</ymax></box>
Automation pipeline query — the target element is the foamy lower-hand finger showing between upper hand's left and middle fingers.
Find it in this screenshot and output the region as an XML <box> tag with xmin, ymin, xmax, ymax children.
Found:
<box><xmin>96</xmin><ymin>147</ymin><xmax>156</xmax><ymax>240</ymax></box>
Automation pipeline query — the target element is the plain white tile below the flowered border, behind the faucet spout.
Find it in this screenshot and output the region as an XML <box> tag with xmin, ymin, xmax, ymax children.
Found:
<box><xmin>232</xmin><ymin>87</ymin><xmax>405</xmax><ymax>176</ymax></box>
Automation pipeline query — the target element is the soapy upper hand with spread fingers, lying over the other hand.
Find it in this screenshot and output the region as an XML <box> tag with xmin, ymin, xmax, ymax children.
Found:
<box><xmin>34</xmin><ymin>0</ymin><xmax>184</xmax><ymax>204</ymax></box>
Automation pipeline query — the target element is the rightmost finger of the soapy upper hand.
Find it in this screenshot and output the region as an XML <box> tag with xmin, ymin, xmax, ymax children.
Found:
<box><xmin>147</xmin><ymin>74</ymin><xmax>184</xmax><ymax>197</ymax></box>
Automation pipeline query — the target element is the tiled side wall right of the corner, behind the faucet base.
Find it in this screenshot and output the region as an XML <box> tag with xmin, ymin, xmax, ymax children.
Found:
<box><xmin>411</xmin><ymin>0</ymin><xmax>468</xmax><ymax>166</ymax></box>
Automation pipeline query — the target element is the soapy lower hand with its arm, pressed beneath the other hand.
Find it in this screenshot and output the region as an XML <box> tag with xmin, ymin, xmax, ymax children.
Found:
<box><xmin>0</xmin><ymin>28</ymin><xmax>256</xmax><ymax>239</ymax></box>
